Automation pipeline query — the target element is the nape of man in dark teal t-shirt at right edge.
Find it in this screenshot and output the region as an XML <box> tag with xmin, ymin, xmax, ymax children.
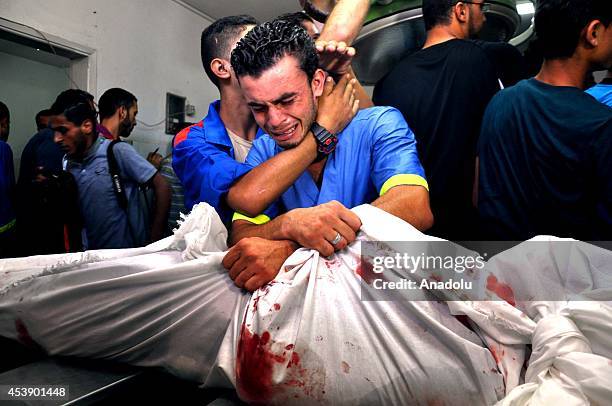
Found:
<box><xmin>535</xmin><ymin>57</ymin><xmax>589</xmax><ymax>89</ymax></box>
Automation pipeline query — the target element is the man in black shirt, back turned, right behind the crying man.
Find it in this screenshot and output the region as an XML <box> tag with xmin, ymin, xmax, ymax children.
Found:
<box><xmin>374</xmin><ymin>0</ymin><xmax>500</xmax><ymax>239</ymax></box>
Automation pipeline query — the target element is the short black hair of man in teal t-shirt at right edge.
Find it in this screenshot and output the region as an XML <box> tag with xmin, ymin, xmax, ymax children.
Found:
<box><xmin>535</xmin><ymin>0</ymin><xmax>612</xmax><ymax>59</ymax></box>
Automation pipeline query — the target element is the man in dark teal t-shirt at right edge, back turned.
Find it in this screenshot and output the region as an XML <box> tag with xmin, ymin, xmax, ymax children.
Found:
<box><xmin>478</xmin><ymin>0</ymin><xmax>612</xmax><ymax>240</ymax></box>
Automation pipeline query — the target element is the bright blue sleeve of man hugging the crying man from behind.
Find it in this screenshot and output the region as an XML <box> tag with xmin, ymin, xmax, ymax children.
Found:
<box><xmin>172</xmin><ymin>129</ymin><xmax>251</xmax><ymax>213</ymax></box>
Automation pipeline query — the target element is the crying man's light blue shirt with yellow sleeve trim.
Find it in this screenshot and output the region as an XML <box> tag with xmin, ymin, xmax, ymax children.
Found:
<box><xmin>234</xmin><ymin>107</ymin><xmax>428</xmax><ymax>224</ymax></box>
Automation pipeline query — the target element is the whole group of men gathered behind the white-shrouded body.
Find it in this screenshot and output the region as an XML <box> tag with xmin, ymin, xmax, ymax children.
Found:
<box><xmin>0</xmin><ymin>0</ymin><xmax>612</xmax><ymax>282</ymax></box>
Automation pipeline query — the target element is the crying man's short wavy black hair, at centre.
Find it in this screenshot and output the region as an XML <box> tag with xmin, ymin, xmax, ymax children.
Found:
<box><xmin>232</xmin><ymin>20</ymin><xmax>319</xmax><ymax>80</ymax></box>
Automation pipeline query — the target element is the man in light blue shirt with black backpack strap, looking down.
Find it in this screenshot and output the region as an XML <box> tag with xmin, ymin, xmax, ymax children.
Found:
<box><xmin>51</xmin><ymin>90</ymin><xmax>170</xmax><ymax>249</ymax></box>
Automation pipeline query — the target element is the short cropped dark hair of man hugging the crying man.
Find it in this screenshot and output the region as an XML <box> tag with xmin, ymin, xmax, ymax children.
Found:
<box><xmin>200</xmin><ymin>14</ymin><xmax>258</xmax><ymax>87</ymax></box>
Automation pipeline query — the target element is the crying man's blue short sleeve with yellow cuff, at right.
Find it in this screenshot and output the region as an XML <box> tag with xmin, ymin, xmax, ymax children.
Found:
<box><xmin>369</xmin><ymin>108</ymin><xmax>429</xmax><ymax>196</ymax></box>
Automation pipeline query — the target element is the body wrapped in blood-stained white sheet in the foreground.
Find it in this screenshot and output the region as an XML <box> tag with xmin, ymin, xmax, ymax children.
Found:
<box><xmin>0</xmin><ymin>204</ymin><xmax>612</xmax><ymax>405</ymax></box>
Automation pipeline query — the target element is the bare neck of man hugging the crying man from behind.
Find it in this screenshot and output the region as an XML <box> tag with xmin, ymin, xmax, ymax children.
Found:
<box><xmin>219</xmin><ymin>90</ymin><xmax>257</xmax><ymax>141</ymax></box>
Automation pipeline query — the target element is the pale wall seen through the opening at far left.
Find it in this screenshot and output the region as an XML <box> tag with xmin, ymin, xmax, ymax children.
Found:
<box><xmin>0</xmin><ymin>52</ymin><xmax>69</xmax><ymax>176</ymax></box>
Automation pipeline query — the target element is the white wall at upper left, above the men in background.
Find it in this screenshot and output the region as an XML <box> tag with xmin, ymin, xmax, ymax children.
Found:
<box><xmin>0</xmin><ymin>0</ymin><xmax>218</xmax><ymax>158</ymax></box>
